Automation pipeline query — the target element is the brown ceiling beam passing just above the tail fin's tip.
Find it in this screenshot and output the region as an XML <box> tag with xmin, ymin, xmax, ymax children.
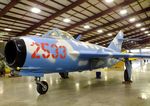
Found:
<box><xmin>82</xmin><ymin>17</ymin><xmax>150</xmax><ymax>42</ymax></box>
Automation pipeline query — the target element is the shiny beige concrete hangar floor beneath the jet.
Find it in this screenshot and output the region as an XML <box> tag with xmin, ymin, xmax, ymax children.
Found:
<box><xmin>0</xmin><ymin>62</ymin><xmax>150</xmax><ymax>106</ymax></box>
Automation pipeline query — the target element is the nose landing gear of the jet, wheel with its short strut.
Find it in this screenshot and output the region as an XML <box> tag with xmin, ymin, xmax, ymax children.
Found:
<box><xmin>35</xmin><ymin>77</ymin><xmax>48</xmax><ymax>95</ymax></box>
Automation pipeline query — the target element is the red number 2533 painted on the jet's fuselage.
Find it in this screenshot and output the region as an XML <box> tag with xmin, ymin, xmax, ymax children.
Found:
<box><xmin>30</xmin><ymin>42</ymin><xmax>66</xmax><ymax>59</ymax></box>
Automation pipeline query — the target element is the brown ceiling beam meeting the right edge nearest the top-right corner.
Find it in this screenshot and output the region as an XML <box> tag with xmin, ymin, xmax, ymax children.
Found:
<box><xmin>80</xmin><ymin>7</ymin><xmax>150</xmax><ymax>35</ymax></box>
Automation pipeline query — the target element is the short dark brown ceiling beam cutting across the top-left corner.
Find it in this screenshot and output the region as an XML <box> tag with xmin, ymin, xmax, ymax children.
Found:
<box><xmin>0</xmin><ymin>0</ymin><xmax>20</xmax><ymax>17</ymax></box>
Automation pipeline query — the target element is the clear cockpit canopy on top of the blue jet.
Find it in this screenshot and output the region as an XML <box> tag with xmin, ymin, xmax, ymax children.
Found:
<box><xmin>42</xmin><ymin>28</ymin><xmax>74</xmax><ymax>40</ymax></box>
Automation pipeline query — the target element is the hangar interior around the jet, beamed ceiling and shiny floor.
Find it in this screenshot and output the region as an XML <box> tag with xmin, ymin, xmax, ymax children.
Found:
<box><xmin>0</xmin><ymin>0</ymin><xmax>150</xmax><ymax>106</ymax></box>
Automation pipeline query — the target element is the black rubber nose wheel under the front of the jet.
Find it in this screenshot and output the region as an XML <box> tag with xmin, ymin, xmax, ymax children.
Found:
<box><xmin>37</xmin><ymin>81</ymin><xmax>48</xmax><ymax>95</ymax></box>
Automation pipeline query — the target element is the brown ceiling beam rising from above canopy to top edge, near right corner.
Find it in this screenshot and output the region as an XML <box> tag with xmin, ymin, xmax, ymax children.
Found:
<box><xmin>64</xmin><ymin>0</ymin><xmax>136</xmax><ymax>31</ymax></box>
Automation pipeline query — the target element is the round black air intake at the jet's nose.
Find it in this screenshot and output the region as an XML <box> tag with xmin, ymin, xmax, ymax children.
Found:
<box><xmin>4</xmin><ymin>39</ymin><xmax>26</xmax><ymax>67</ymax></box>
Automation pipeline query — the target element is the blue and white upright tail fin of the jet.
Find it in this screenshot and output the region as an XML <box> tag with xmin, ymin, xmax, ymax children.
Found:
<box><xmin>108</xmin><ymin>31</ymin><xmax>124</xmax><ymax>52</ymax></box>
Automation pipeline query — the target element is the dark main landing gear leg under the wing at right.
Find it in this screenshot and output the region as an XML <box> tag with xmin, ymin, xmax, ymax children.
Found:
<box><xmin>123</xmin><ymin>58</ymin><xmax>132</xmax><ymax>84</ymax></box>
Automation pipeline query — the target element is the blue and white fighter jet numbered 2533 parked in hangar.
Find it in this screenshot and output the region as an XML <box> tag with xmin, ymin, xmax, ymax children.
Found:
<box><xmin>5</xmin><ymin>29</ymin><xmax>150</xmax><ymax>94</ymax></box>
